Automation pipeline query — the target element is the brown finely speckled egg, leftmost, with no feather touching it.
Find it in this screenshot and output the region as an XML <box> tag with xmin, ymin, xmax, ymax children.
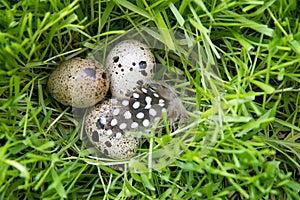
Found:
<box><xmin>48</xmin><ymin>58</ymin><xmax>110</xmax><ymax>108</ymax></box>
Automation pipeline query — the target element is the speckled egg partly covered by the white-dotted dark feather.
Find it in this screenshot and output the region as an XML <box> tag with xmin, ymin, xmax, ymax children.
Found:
<box><xmin>85</xmin><ymin>99</ymin><xmax>139</xmax><ymax>160</ymax></box>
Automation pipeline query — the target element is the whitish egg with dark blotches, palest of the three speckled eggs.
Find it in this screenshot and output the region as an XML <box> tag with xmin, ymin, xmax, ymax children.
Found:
<box><xmin>105</xmin><ymin>40</ymin><xmax>155</xmax><ymax>97</ymax></box>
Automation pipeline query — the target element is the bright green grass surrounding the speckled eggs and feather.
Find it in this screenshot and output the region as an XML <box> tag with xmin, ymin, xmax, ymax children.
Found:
<box><xmin>0</xmin><ymin>0</ymin><xmax>300</xmax><ymax>199</ymax></box>
